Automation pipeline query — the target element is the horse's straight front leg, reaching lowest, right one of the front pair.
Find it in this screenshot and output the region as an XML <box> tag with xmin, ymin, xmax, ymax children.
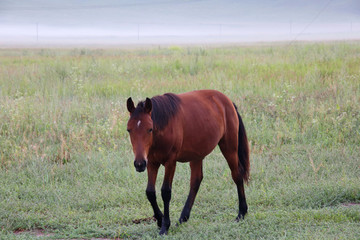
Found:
<box><xmin>160</xmin><ymin>161</ymin><xmax>176</xmax><ymax>235</ymax></box>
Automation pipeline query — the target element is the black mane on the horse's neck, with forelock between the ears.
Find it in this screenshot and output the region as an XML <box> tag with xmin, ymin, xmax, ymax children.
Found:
<box><xmin>132</xmin><ymin>93</ymin><xmax>181</xmax><ymax>130</ymax></box>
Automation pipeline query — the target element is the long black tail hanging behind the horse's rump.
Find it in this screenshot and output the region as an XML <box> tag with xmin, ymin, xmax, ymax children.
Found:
<box><xmin>233</xmin><ymin>103</ymin><xmax>250</xmax><ymax>182</ymax></box>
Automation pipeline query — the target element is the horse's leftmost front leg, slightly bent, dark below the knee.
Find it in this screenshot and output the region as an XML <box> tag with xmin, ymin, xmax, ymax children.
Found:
<box><xmin>146</xmin><ymin>164</ymin><xmax>164</xmax><ymax>228</ymax></box>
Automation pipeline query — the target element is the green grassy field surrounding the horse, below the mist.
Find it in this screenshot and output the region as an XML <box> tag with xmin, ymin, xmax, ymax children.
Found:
<box><xmin>0</xmin><ymin>42</ymin><xmax>360</xmax><ymax>239</ymax></box>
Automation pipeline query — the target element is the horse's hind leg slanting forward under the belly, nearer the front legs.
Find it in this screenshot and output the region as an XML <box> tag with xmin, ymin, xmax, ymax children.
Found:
<box><xmin>179</xmin><ymin>160</ymin><xmax>203</xmax><ymax>223</ymax></box>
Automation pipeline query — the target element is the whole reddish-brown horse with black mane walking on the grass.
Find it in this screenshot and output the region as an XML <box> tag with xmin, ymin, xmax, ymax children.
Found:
<box><xmin>127</xmin><ymin>90</ymin><xmax>250</xmax><ymax>234</ymax></box>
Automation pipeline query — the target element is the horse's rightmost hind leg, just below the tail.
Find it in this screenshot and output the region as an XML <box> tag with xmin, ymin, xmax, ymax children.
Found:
<box><xmin>219</xmin><ymin>141</ymin><xmax>248</xmax><ymax>221</ymax></box>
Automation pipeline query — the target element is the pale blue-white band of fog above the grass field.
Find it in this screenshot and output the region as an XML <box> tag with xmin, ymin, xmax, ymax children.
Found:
<box><xmin>0</xmin><ymin>0</ymin><xmax>360</xmax><ymax>47</ymax></box>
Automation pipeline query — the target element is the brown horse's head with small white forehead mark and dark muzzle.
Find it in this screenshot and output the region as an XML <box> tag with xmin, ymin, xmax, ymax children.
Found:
<box><xmin>127</xmin><ymin>98</ymin><xmax>153</xmax><ymax>172</ymax></box>
